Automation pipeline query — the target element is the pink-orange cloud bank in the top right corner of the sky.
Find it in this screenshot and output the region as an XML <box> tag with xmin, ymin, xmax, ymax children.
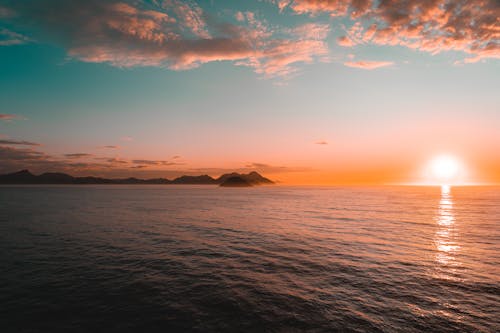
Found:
<box><xmin>275</xmin><ymin>0</ymin><xmax>500</xmax><ymax>63</ymax></box>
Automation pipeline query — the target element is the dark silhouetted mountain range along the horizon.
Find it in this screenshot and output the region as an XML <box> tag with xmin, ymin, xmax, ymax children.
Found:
<box><xmin>0</xmin><ymin>170</ymin><xmax>274</xmax><ymax>186</ymax></box>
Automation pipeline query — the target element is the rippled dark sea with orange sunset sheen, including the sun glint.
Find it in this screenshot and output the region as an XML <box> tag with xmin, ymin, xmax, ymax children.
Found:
<box><xmin>0</xmin><ymin>186</ymin><xmax>500</xmax><ymax>332</ymax></box>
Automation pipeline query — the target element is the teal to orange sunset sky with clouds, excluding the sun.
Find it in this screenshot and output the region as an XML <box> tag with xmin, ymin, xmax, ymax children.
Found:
<box><xmin>0</xmin><ymin>0</ymin><xmax>500</xmax><ymax>185</ymax></box>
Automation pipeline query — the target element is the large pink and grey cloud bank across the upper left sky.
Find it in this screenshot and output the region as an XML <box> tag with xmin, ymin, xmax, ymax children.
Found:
<box><xmin>4</xmin><ymin>0</ymin><xmax>328</xmax><ymax>78</ymax></box>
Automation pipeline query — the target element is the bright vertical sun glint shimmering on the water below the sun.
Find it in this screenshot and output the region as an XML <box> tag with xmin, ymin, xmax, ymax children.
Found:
<box><xmin>434</xmin><ymin>185</ymin><xmax>460</xmax><ymax>272</ymax></box>
